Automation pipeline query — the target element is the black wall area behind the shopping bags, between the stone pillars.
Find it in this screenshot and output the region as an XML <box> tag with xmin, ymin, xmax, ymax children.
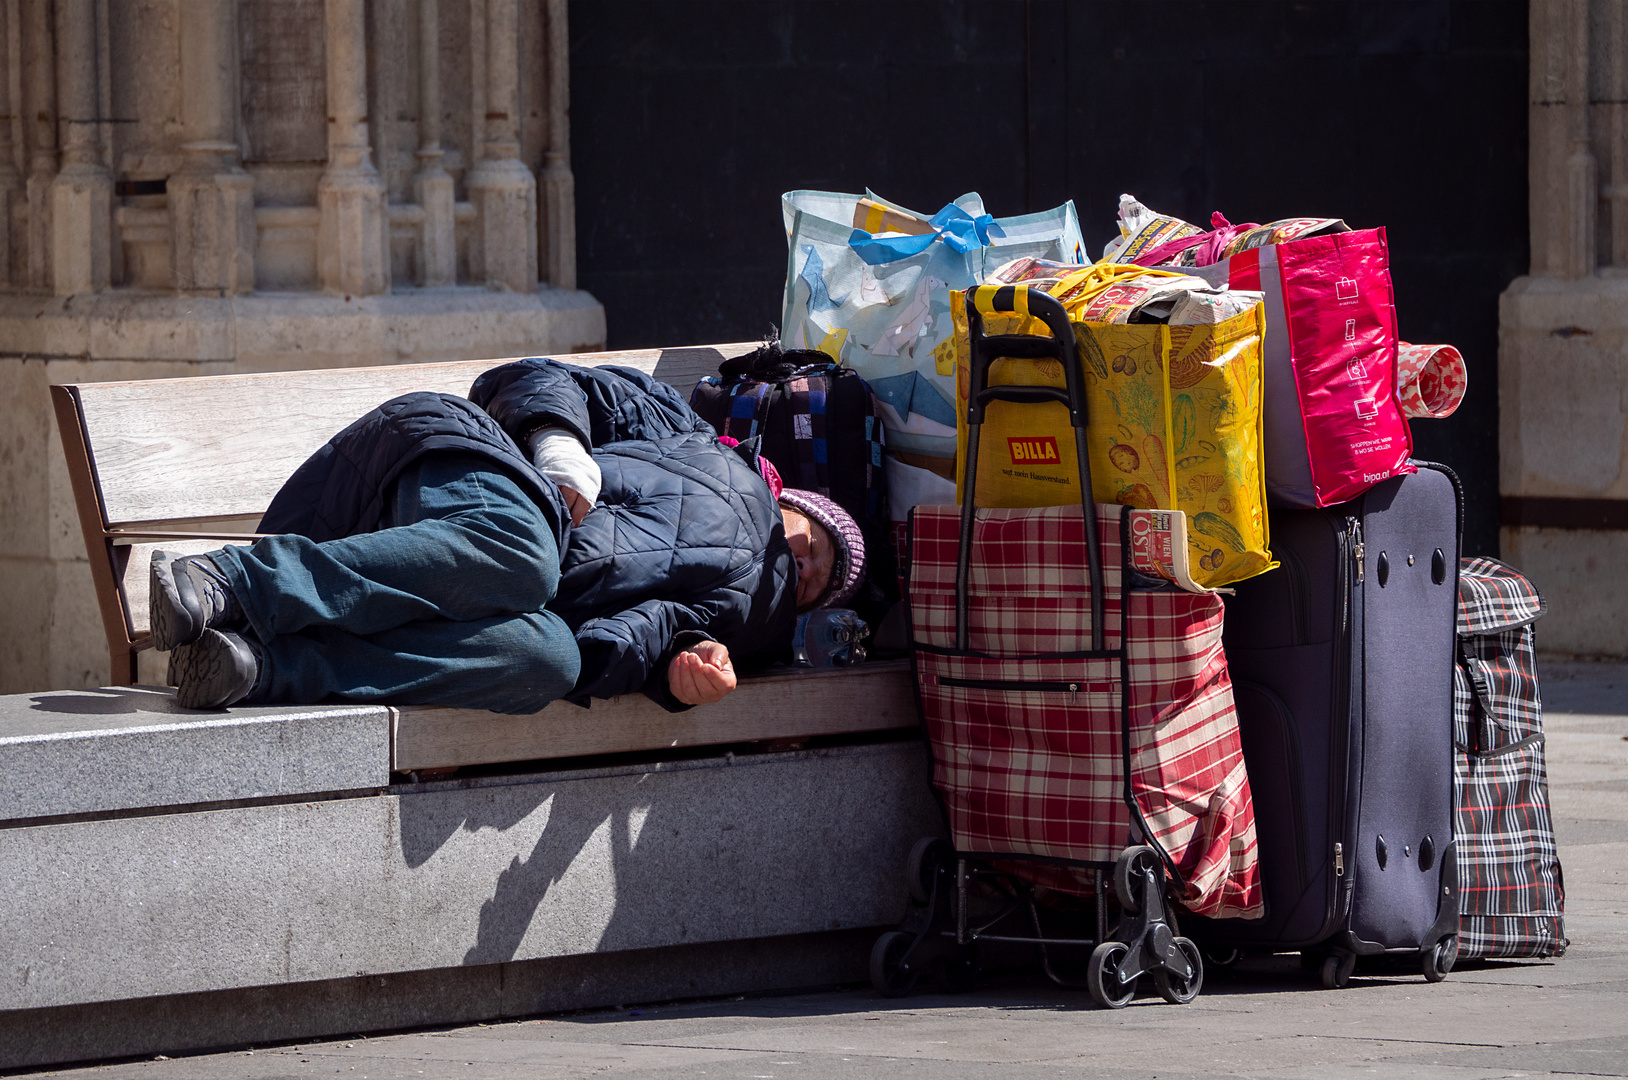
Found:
<box><xmin>570</xmin><ymin>0</ymin><xmax>1527</xmax><ymax>554</ymax></box>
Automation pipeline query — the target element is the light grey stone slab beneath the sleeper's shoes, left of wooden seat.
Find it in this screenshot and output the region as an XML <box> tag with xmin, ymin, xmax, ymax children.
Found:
<box><xmin>0</xmin><ymin>686</ymin><xmax>391</xmax><ymax>823</ymax></box>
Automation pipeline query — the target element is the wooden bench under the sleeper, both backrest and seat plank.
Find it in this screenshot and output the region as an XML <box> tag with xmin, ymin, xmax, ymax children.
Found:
<box><xmin>52</xmin><ymin>342</ymin><xmax>917</xmax><ymax>772</ymax></box>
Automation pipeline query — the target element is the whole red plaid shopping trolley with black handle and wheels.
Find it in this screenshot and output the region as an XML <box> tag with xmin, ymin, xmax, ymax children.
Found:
<box><xmin>873</xmin><ymin>287</ymin><xmax>1262</xmax><ymax>1008</ymax></box>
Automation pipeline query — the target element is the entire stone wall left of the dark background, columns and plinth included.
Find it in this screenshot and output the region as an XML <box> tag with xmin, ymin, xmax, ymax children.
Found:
<box><xmin>0</xmin><ymin>0</ymin><xmax>606</xmax><ymax>692</ymax></box>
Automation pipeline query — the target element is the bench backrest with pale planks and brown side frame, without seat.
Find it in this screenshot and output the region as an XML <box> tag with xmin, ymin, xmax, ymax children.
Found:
<box><xmin>50</xmin><ymin>342</ymin><xmax>757</xmax><ymax>686</ymax></box>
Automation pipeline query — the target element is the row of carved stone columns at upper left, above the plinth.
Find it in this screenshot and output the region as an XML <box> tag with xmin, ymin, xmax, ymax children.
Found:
<box><xmin>0</xmin><ymin>0</ymin><xmax>575</xmax><ymax>296</ymax></box>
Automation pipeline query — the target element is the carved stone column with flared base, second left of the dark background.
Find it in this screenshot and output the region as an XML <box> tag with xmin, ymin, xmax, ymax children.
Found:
<box><xmin>469</xmin><ymin>0</ymin><xmax>537</xmax><ymax>293</ymax></box>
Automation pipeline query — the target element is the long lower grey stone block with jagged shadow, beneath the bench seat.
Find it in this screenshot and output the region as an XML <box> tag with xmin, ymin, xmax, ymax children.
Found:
<box><xmin>0</xmin><ymin>741</ymin><xmax>943</xmax><ymax>1010</ymax></box>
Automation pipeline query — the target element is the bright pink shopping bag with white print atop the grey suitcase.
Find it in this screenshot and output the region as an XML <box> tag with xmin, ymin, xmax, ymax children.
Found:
<box><xmin>1224</xmin><ymin>228</ymin><xmax>1415</xmax><ymax>507</ymax></box>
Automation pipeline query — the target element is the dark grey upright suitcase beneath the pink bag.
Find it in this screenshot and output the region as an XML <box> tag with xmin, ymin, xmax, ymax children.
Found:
<box><xmin>1184</xmin><ymin>463</ymin><xmax>1462</xmax><ymax>989</ymax></box>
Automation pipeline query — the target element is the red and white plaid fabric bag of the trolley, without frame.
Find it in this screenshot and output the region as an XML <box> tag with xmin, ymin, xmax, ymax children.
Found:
<box><xmin>910</xmin><ymin>507</ymin><xmax>1263</xmax><ymax>919</ymax></box>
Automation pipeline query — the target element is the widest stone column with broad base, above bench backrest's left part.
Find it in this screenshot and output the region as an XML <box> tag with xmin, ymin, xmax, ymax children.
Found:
<box><xmin>164</xmin><ymin>0</ymin><xmax>254</xmax><ymax>296</ymax></box>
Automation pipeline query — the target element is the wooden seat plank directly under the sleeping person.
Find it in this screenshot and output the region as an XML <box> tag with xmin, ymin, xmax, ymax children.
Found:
<box><xmin>391</xmin><ymin>660</ymin><xmax>920</xmax><ymax>772</ymax></box>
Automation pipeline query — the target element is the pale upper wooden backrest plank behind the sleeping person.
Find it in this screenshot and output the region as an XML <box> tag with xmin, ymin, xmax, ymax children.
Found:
<box><xmin>68</xmin><ymin>342</ymin><xmax>757</xmax><ymax>526</ymax></box>
